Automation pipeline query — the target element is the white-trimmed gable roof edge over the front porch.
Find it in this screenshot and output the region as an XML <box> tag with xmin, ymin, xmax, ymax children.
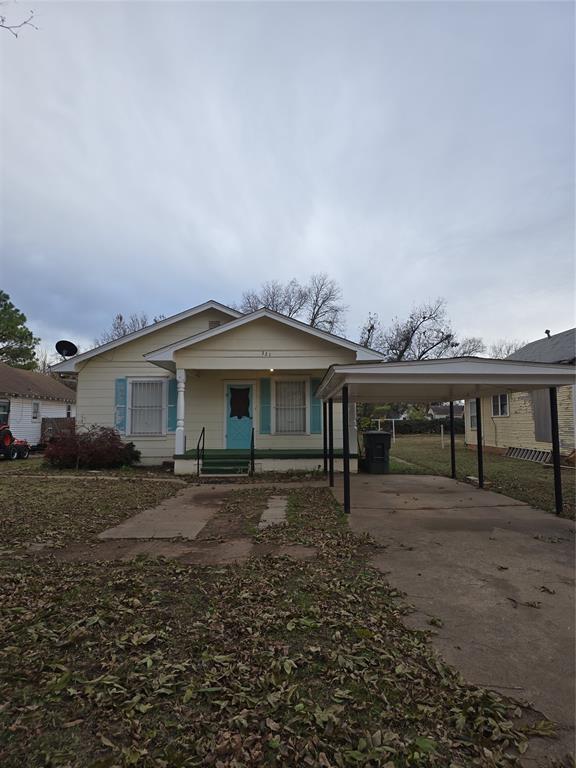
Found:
<box><xmin>144</xmin><ymin>308</ymin><xmax>382</xmax><ymax>363</ymax></box>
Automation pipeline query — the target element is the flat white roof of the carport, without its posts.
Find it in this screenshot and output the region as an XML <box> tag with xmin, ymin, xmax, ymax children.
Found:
<box><xmin>316</xmin><ymin>357</ymin><xmax>576</xmax><ymax>403</ymax></box>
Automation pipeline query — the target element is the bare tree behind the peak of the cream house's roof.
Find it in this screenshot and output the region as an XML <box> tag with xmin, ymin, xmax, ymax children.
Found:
<box><xmin>240</xmin><ymin>273</ymin><xmax>346</xmax><ymax>332</ymax></box>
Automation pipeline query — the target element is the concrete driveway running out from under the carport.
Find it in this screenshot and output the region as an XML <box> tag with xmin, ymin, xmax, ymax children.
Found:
<box><xmin>336</xmin><ymin>475</ymin><xmax>575</xmax><ymax>766</ymax></box>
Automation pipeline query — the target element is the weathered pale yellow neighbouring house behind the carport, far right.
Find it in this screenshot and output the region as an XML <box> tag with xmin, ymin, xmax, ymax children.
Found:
<box><xmin>465</xmin><ymin>328</ymin><xmax>576</xmax><ymax>454</ymax></box>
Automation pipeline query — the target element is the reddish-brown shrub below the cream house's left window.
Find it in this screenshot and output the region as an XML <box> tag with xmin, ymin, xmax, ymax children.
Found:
<box><xmin>44</xmin><ymin>426</ymin><xmax>140</xmax><ymax>469</ymax></box>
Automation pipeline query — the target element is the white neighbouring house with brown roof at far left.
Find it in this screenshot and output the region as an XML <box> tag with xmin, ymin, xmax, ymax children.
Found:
<box><xmin>0</xmin><ymin>363</ymin><xmax>76</xmax><ymax>447</ymax></box>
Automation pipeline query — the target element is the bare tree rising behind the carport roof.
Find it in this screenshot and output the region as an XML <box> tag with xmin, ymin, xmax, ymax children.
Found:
<box><xmin>360</xmin><ymin>299</ymin><xmax>485</xmax><ymax>361</ymax></box>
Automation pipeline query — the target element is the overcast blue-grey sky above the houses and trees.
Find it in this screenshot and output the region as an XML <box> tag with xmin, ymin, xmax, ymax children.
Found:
<box><xmin>0</xmin><ymin>2</ymin><xmax>574</xmax><ymax>348</ymax></box>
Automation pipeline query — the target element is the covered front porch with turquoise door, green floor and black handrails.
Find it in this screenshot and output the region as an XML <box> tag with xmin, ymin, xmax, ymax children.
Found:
<box><xmin>168</xmin><ymin>369</ymin><xmax>357</xmax><ymax>476</ymax></box>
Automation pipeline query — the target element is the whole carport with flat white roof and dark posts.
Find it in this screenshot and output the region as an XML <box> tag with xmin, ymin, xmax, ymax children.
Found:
<box><xmin>316</xmin><ymin>357</ymin><xmax>576</xmax><ymax>514</ymax></box>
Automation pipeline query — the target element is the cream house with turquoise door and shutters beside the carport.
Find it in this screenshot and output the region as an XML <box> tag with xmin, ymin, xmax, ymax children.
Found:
<box><xmin>53</xmin><ymin>301</ymin><xmax>381</xmax><ymax>474</ymax></box>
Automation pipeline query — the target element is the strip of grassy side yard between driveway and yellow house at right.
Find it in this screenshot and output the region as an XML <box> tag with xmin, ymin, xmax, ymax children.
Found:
<box><xmin>390</xmin><ymin>435</ymin><xmax>575</xmax><ymax>518</ymax></box>
